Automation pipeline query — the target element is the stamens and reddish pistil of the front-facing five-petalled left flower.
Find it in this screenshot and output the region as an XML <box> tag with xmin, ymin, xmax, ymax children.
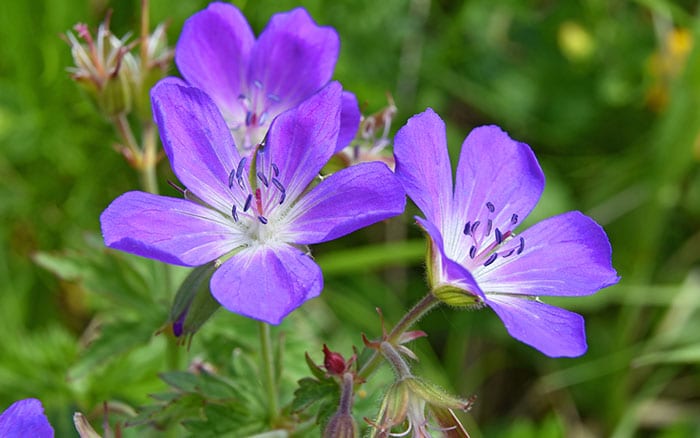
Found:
<box><xmin>228</xmin><ymin>145</ymin><xmax>287</xmax><ymax>229</ymax></box>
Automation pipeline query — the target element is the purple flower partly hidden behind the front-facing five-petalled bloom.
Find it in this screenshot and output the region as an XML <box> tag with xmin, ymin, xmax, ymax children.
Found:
<box><xmin>175</xmin><ymin>3</ymin><xmax>360</xmax><ymax>151</ymax></box>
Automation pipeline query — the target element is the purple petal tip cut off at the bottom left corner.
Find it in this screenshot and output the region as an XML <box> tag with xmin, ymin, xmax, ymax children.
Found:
<box><xmin>0</xmin><ymin>398</ymin><xmax>53</xmax><ymax>438</ymax></box>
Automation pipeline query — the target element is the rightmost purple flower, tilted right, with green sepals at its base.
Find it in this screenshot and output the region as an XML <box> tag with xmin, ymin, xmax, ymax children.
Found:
<box><xmin>395</xmin><ymin>109</ymin><xmax>619</xmax><ymax>357</ymax></box>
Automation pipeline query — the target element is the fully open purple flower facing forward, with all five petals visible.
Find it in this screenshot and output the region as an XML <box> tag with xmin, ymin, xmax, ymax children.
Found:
<box><xmin>100</xmin><ymin>82</ymin><xmax>405</xmax><ymax>324</ymax></box>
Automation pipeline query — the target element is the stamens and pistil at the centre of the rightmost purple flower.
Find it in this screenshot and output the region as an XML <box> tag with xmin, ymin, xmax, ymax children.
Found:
<box><xmin>463</xmin><ymin>201</ymin><xmax>525</xmax><ymax>266</ymax></box>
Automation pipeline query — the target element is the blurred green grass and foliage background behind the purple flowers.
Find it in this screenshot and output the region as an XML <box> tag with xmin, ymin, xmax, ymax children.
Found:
<box><xmin>0</xmin><ymin>0</ymin><xmax>700</xmax><ymax>437</ymax></box>
